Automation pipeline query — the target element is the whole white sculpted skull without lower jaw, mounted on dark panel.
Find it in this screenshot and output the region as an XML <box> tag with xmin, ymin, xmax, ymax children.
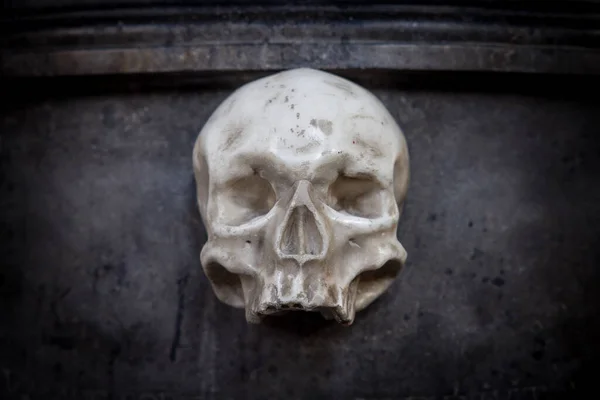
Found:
<box><xmin>194</xmin><ymin>69</ymin><xmax>409</xmax><ymax>324</ymax></box>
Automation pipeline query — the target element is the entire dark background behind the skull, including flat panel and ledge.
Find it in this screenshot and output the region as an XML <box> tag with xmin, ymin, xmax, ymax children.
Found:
<box><xmin>0</xmin><ymin>0</ymin><xmax>600</xmax><ymax>400</ymax></box>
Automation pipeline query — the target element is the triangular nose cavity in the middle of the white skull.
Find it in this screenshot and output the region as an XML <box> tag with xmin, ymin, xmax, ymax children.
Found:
<box><xmin>279</xmin><ymin>205</ymin><xmax>323</xmax><ymax>256</ymax></box>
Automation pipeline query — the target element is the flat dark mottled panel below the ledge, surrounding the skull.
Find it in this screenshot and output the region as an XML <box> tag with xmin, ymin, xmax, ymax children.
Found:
<box><xmin>0</xmin><ymin>72</ymin><xmax>600</xmax><ymax>400</ymax></box>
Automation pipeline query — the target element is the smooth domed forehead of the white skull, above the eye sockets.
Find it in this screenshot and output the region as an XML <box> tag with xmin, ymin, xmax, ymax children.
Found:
<box><xmin>200</xmin><ymin>69</ymin><xmax>403</xmax><ymax>181</ymax></box>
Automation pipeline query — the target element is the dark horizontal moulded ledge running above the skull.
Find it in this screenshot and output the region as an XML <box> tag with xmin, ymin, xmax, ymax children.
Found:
<box><xmin>0</xmin><ymin>0</ymin><xmax>600</xmax><ymax>77</ymax></box>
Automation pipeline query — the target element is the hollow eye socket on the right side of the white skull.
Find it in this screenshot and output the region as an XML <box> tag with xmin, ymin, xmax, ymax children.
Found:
<box><xmin>328</xmin><ymin>175</ymin><xmax>383</xmax><ymax>218</ymax></box>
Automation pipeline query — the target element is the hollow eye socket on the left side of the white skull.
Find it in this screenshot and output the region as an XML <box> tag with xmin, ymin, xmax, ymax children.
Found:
<box><xmin>217</xmin><ymin>174</ymin><xmax>276</xmax><ymax>225</ymax></box>
